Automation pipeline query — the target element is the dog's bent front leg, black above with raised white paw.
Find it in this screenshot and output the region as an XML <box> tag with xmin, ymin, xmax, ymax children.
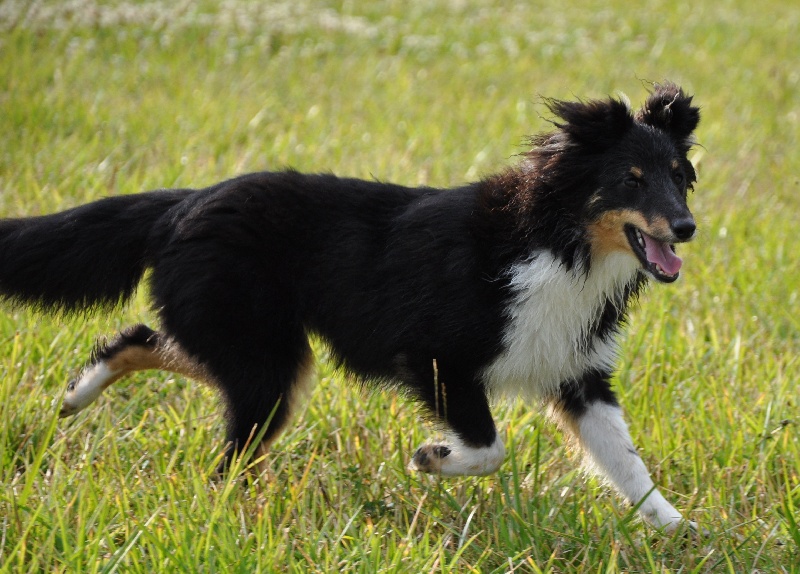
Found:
<box><xmin>409</xmin><ymin>365</ymin><xmax>505</xmax><ymax>476</ymax></box>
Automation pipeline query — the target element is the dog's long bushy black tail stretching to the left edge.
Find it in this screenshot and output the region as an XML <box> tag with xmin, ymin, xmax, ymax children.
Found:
<box><xmin>0</xmin><ymin>190</ymin><xmax>191</xmax><ymax>313</ymax></box>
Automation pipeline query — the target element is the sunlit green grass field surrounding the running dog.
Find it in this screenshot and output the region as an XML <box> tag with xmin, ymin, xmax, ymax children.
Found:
<box><xmin>0</xmin><ymin>0</ymin><xmax>800</xmax><ymax>573</ymax></box>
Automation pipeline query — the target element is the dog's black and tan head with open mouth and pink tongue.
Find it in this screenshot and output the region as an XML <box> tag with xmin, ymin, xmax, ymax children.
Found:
<box><xmin>537</xmin><ymin>84</ymin><xmax>700</xmax><ymax>283</ymax></box>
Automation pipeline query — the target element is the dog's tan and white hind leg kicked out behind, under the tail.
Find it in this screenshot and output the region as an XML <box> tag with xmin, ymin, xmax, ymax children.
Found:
<box><xmin>59</xmin><ymin>325</ymin><xmax>206</xmax><ymax>417</ymax></box>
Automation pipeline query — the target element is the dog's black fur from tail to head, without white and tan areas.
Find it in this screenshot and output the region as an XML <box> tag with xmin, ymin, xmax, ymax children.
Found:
<box><xmin>0</xmin><ymin>84</ymin><xmax>699</xmax><ymax>472</ymax></box>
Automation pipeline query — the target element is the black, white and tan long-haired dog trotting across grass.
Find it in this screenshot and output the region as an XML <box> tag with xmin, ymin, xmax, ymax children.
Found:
<box><xmin>0</xmin><ymin>82</ymin><xmax>700</xmax><ymax>531</ymax></box>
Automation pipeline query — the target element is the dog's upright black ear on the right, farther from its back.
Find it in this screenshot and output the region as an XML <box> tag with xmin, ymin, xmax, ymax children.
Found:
<box><xmin>636</xmin><ymin>82</ymin><xmax>700</xmax><ymax>149</ymax></box>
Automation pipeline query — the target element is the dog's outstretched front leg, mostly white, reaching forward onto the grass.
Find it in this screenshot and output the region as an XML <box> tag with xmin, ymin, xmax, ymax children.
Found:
<box><xmin>553</xmin><ymin>375</ymin><xmax>696</xmax><ymax>532</ymax></box>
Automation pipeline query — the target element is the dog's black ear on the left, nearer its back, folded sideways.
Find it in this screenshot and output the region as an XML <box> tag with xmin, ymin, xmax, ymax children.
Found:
<box><xmin>546</xmin><ymin>98</ymin><xmax>633</xmax><ymax>150</ymax></box>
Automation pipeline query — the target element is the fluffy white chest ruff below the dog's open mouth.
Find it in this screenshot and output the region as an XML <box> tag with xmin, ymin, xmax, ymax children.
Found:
<box><xmin>484</xmin><ymin>250</ymin><xmax>639</xmax><ymax>400</ymax></box>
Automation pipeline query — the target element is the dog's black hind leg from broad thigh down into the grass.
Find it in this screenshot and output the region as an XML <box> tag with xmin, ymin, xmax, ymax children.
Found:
<box><xmin>151</xmin><ymin>230</ymin><xmax>313</xmax><ymax>471</ymax></box>
